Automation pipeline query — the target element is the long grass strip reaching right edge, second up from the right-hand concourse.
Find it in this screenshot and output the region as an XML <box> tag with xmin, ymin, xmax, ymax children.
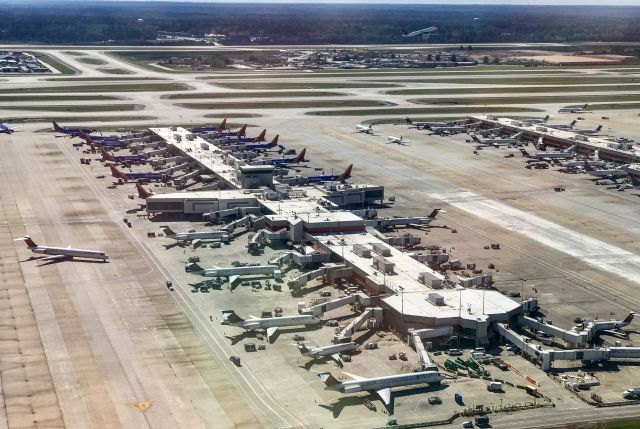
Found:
<box><xmin>386</xmin><ymin>85</ymin><xmax>640</xmax><ymax>95</ymax></box>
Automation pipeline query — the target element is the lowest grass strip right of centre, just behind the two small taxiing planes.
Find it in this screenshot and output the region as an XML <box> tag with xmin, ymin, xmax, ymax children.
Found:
<box><xmin>307</xmin><ymin>106</ymin><xmax>542</xmax><ymax>116</ymax></box>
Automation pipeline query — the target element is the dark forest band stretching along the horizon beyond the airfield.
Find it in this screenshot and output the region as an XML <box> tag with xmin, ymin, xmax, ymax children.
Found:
<box><xmin>0</xmin><ymin>0</ymin><xmax>640</xmax><ymax>45</ymax></box>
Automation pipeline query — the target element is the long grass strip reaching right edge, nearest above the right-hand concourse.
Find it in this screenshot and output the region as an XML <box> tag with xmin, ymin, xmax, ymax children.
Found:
<box><xmin>408</xmin><ymin>94</ymin><xmax>640</xmax><ymax>106</ymax></box>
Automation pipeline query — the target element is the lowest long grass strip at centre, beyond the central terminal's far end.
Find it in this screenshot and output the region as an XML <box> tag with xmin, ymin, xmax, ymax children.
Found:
<box><xmin>176</xmin><ymin>100</ymin><xmax>395</xmax><ymax>110</ymax></box>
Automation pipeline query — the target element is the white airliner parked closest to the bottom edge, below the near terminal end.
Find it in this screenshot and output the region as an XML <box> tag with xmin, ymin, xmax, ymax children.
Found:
<box><xmin>318</xmin><ymin>371</ymin><xmax>444</xmax><ymax>405</ymax></box>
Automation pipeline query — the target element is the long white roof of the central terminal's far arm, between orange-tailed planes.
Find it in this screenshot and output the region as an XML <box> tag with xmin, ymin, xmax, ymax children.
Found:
<box><xmin>150</xmin><ymin>127</ymin><xmax>241</xmax><ymax>189</ymax></box>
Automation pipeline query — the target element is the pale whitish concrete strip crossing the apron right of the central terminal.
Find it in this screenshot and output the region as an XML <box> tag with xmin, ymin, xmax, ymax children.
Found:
<box><xmin>429</xmin><ymin>191</ymin><xmax>640</xmax><ymax>284</ymax></box>
